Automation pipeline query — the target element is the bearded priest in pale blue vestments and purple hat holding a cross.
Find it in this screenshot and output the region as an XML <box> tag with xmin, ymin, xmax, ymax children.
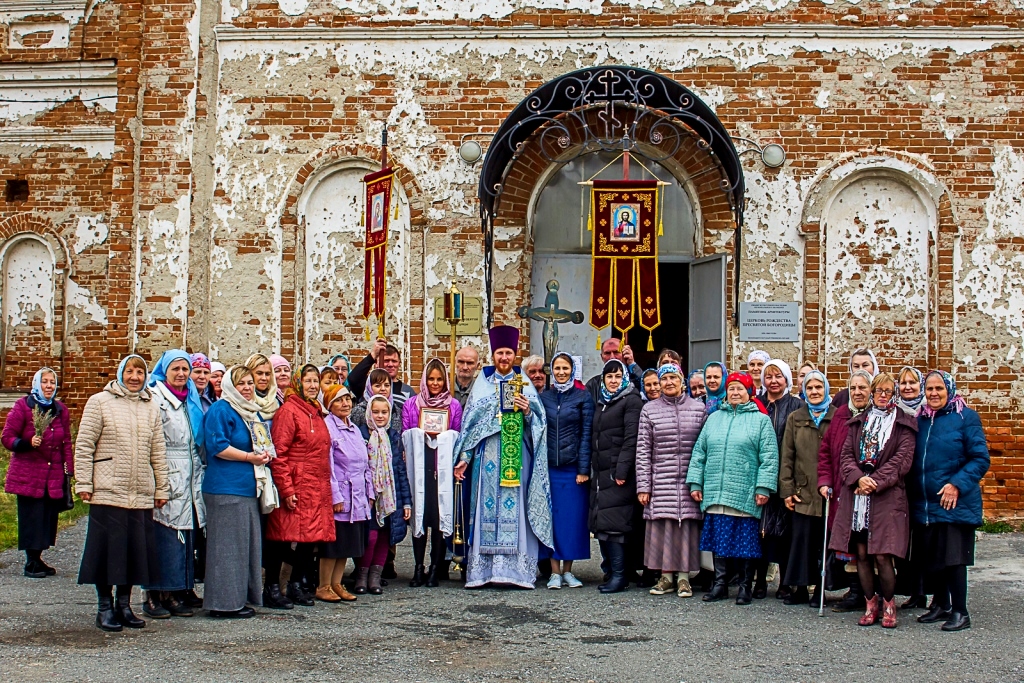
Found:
<box><xmin>455</xmin><ymin>326</ymin><xmax>553</xmax><ymax>588</ymax></box>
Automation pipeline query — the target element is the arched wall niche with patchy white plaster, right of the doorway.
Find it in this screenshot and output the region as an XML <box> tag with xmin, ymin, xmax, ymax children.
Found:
<box><xmin>821</xmin><ymin>168</ymin><xmax>937</xmax><ymax>376</ymax></box>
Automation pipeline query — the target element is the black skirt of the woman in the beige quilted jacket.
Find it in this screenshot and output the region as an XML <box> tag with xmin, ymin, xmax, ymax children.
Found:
<box><xmin>78</xmin><ymin>505</ymin><xmax>160</xmax><ymax>586</ymax></box>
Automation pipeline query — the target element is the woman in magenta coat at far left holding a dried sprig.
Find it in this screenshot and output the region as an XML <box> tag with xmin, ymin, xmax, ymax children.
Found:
<box><xmin>2</xmin><ymin>368</ymin><xmax>75</xmax><ymax>579</ymax></box>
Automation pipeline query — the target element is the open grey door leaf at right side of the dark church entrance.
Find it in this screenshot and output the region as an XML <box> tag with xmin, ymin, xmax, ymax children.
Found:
<box><xmin>689</xmin><ymin>254</ymin><xmax>726</xmax><ymax>370</ymax></box>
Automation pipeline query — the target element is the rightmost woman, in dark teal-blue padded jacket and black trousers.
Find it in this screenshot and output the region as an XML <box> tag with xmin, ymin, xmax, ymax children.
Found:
<box><xmin>907</xmin><ymin>370</ymin><xmax>989</xmax><ymax>631</ymax></box>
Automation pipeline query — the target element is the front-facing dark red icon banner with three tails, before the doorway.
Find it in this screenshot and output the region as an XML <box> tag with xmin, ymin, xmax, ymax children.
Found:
<box><xmin>589</xmin><ymin>179</ymin><xmax>663</xmax><ymax>350</ymax></box>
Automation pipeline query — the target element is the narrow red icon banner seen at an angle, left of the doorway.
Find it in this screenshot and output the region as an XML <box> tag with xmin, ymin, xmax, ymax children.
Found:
<box><xmin>362</xmin><ymin>168</ymin><xmax>397</xmax><ymax>325</ymax></box>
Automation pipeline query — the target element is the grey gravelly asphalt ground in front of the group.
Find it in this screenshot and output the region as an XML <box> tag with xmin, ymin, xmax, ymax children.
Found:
<box><xmin>0</xmin><ymin>520</ymin><xmax>1024</xmax><ymax>683</ymax></box>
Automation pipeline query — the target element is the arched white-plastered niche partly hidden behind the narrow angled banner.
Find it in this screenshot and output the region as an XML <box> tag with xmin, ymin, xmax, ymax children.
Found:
<box><xmin>297</xmin><ymin>158</ymin><xmax>410</xmax><ymax>365</ymax></box>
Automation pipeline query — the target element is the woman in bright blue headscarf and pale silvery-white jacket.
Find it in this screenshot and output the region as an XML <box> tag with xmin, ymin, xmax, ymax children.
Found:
<box><xmin>142</xmin><ymin>350</ymin><xmax>206</xmax><ymax>618</ymax></box>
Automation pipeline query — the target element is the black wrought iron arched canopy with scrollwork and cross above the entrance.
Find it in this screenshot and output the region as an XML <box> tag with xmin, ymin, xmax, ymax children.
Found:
<box><xmin>478</xmin><ymin>66</ymin><xmax>744</xmax><ymax>324</ymax></box>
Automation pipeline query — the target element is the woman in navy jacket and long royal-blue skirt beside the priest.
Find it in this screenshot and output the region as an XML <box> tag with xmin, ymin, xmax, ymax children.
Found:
<box><xmin>536</xmin><ymin>351</ymin><xmax>594</xmax><ymax>589</ymax></box>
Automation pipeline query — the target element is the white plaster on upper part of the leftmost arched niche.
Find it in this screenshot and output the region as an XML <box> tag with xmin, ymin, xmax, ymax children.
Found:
<box><xmin>3</xmin><ymin>238</ymin><xmax>54</xmax><ymax>330</ymax></box>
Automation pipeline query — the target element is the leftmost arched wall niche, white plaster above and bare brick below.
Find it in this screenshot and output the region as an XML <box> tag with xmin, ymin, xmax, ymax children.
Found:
<box><xmin>0</xmin><ymin>233</ymin><xmax>57</xmax><ymax>388</ymax></box>
